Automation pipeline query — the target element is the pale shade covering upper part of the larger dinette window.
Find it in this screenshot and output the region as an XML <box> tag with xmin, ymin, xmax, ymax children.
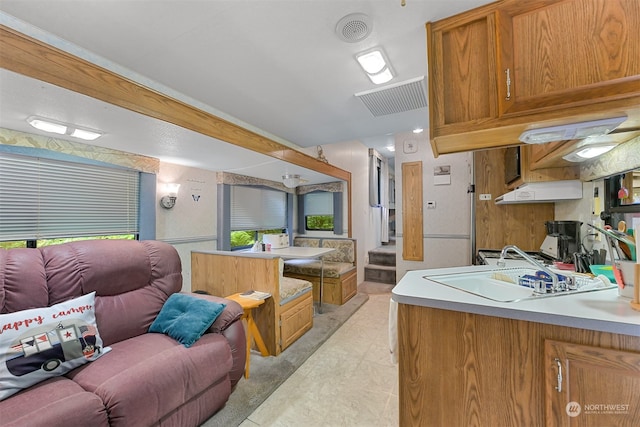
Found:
<box><xmin>231</xmin><ymin>185</ymin><xmax>287</xmax><ymax>231</ymax></box>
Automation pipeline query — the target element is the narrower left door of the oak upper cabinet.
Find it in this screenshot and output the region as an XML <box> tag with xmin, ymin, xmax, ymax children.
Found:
<box><xmin>427</xmin><ymin>13</ymin><xmax>497</xmax><ymax>137</ymax></box>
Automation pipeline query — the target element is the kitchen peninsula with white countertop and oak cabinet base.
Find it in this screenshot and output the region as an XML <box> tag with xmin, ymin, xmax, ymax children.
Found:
<box><xmin>392</xmin><ymin>266</ymin><xmax>640</xmax><ymax>427</ymax></box>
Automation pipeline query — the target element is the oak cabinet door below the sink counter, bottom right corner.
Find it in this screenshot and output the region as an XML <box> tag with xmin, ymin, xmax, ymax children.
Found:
<box><xmin>544</xmin><ymin>340</ymin><xmax>640</xmax><ymax>427</ymax></box>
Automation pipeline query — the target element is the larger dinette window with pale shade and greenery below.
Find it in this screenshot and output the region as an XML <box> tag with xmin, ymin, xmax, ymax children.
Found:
<box><xmin>231</xmin><ymin>186</ymin><xmax>287</xmax><ymax>250</ymax></box>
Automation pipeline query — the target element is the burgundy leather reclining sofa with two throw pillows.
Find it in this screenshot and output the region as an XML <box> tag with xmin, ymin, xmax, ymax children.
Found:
<box><xmin>0</xmin><ymin>240</ymin><xmax>246</xmax><ymax>427</ymax></box>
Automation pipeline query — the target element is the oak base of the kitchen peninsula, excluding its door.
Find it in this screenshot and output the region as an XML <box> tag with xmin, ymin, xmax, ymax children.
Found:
<box><xmin>398</xmin><ymin>304</ymin><xmax>640</xmax><ymax>427</ymax></box>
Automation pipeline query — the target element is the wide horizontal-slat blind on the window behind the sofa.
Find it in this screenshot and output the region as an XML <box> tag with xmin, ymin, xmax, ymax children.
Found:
<box><xmin>0</xmin><ymin>153</ymin><xmax>139</xmax><ymax>241</ymax></box>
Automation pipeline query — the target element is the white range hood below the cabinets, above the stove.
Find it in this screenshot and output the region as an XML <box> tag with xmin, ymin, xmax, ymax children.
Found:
<box><xmin>495</xmin><ymin>179</ymin><xmax>582</xmax><ymax>205</ymax></box>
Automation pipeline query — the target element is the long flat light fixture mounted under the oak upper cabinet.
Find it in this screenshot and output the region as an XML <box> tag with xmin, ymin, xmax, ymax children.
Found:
<box><xmin>520</xmin><ymin>116</ymin><xmax>627</xmax><ymax>144</ymax></box>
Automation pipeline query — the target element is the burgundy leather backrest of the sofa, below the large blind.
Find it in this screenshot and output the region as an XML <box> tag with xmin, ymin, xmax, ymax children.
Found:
<box><xmin>0</xmin><ymin>240</ymin><xmax>182</xmax><ymax>345</ymax></box>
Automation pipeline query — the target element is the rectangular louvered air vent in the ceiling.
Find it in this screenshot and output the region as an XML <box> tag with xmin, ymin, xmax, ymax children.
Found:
<box><xmin>355</xmin><ymin>76</ymin><xmax>427</xmax><ymax>117</ymax></box>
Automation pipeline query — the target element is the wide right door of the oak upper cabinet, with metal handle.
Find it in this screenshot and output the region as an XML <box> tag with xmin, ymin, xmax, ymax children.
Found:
<box><xmin>497</xmin><ymin>0</ymin><xmax>640</xmax><ymax>115</ymax></box>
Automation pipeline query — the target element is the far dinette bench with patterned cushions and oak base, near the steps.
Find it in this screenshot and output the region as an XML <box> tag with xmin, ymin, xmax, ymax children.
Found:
<box><xmin>284</xmin><ymin>236</ymin><xmax>358</xmax><ymax>305</ymax></box>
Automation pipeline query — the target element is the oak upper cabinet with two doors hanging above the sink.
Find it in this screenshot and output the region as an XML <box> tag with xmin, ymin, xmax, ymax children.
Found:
<box><xmin>427</xmin><ymin>0</ymin><xmax>640</xmax><ymax>157</ymax></box>
